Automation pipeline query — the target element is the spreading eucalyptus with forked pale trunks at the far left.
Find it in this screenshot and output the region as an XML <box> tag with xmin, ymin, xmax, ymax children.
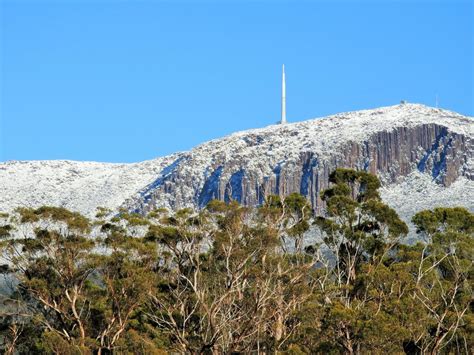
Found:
<box><xmin>1</xmin><ymin>207</ymin><xmax>155</xmax><ymax>354</ymax></box>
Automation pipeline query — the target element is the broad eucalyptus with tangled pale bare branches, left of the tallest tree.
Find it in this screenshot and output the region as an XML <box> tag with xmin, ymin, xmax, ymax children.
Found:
<box><xmin>146</xmin><ymin>201</ymin><xmax>312</xmax><ymax>353</ymax></box>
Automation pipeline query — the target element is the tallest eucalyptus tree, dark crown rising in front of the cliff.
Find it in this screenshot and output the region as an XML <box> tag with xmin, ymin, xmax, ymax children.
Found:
<box><xmin>315</xmin><ymin>169</ymin><xmax>408</xmax><ymax>354</ymax></box>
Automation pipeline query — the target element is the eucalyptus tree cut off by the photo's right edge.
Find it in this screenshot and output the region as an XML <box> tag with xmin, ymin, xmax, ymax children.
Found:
<box><xmin>413</xmin><ymin>207</ymin><xmax>474</xmax><ymax>354</ymax></box>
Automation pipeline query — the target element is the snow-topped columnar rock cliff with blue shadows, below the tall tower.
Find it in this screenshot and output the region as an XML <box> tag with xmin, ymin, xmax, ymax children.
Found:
<box><xmin>126</xmin><ymin>104</ymin><xmax>474</xmax><ymax>217</ymax></box>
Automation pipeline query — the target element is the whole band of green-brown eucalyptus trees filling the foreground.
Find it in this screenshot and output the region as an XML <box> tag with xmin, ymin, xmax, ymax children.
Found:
<box><xmin>0</xmin><ymin>169</ymin><xmax>474</xmax><ymax>354</ymax></box>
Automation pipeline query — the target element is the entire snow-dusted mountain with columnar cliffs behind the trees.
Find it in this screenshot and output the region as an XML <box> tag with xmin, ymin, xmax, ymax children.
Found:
<box><xmin>0</xmin><ymin>104</ymin><xmax>474</xmax><ymax>228</ymax></box>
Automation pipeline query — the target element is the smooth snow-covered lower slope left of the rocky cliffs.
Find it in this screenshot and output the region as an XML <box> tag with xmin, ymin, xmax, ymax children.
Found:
<box><xmin>0</xmin><ymin>154</ymin><xmax>181</xmax><ymax>216</ymax></box>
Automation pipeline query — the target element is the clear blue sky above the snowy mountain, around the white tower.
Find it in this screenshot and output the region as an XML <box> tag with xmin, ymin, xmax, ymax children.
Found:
<box><xmin>0</xmin><ymin>0</ymin><xmax>474</xmax><ymax>162</ymax></box>
